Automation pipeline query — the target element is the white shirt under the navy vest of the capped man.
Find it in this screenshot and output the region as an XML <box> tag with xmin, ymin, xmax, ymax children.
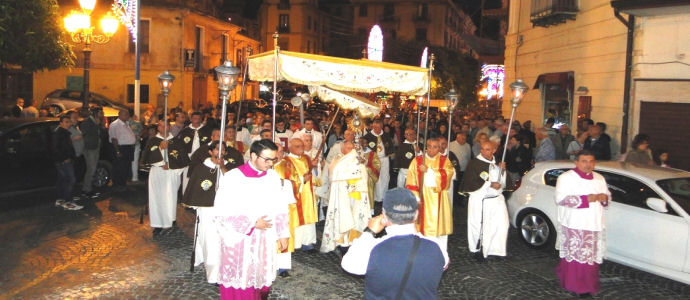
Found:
<box><xmin>340</xmin><ymin>224</ymin><xmax>448</xmax><ymax>275</ymax></box>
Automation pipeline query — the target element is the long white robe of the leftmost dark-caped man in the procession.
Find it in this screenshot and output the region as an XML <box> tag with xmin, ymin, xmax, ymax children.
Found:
<box><xmin>148</xmin><ymin>133</ymin><xmax>183</xmax><ymax>228</ymax></box>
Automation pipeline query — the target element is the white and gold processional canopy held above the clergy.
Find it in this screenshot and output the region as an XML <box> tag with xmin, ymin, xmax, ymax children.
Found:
<box><xmin>249</xmin><ymin>51</ymin><xmax>429</xmax><ymax>95</ymax></box>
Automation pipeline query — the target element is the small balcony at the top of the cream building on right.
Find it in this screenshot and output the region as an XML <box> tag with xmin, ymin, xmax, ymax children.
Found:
<box><xmin>530</xmin><ymin>0</ymin><xmax>579</xmax><ymax>27</ymax></box>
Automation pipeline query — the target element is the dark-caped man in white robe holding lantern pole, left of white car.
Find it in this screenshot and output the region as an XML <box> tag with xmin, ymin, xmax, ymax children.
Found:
<box><xmin>460</xmin><ymin>141</ymin><xmax>509</xmax><ymax>260</ymax></box>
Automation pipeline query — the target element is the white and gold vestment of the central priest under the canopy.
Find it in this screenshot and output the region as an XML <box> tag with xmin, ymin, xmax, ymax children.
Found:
<box><xmin>321</xmin><ymin>150</ymin><xmax>371</xmax><ymax>252</ymax></box>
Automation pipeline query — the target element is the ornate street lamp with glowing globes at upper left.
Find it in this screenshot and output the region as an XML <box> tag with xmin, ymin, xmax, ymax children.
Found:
<box><xmin>64</xmin><ymin>0</ymin><xmax>118</xmax><ymax>108</ymax></box>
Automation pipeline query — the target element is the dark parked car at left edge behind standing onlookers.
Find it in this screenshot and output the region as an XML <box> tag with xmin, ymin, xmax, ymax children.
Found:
<box><xmin>0</xmin><ymin>118</ymin><xmax>113</xmax><ymax>197</ymax></box>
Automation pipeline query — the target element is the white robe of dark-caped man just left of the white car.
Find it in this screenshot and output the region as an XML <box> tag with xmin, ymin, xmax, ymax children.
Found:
<box><xmin>464</xmin><ymin>154</ymin><xmax>509</xmax><ymax>257</ymax></box>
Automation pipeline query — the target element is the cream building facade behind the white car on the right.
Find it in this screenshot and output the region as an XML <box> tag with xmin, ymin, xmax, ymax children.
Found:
<box><xmin>503</xmin><ymin>0</ymin><xmax>690</xmax><ymax>169</ymax></box>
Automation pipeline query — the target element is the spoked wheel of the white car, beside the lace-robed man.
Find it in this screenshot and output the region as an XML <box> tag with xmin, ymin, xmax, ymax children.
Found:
<box><xmin>518</xmin><ymin>210</ymin><xmax>557</xmax><ymax>249</ymax></box>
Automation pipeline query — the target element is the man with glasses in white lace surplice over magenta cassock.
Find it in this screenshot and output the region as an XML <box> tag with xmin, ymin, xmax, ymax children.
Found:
<box><xmin>214</xmin><ymin>139</ymin><xmax>293</xmax><ymax>299</ymax></box>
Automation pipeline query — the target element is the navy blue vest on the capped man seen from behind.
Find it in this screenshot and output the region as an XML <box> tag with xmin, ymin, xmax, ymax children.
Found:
<box><xmin>364</xmin><ymin>235</ymin><xmax>445</xmax><ymax>299</ymax></box>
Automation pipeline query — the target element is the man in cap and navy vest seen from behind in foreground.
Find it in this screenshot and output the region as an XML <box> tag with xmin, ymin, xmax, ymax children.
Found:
<box><xmin>341</xmin><ymin>188</ymin><xmax>448</xmax><ymax>299</ymax></box>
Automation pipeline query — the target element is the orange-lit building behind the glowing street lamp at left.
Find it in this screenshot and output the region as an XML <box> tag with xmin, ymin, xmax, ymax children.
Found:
<box><xmin>33</xmin><ymin>0</ymin><xmax>259</xmax><ymax>113</ymax></box>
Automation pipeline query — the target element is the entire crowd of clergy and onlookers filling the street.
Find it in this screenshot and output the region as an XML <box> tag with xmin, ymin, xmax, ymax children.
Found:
<box><xmin>44</xmin><ymin>98</ymin><xmax>668</xmax><ymax>299</ymax></box>
